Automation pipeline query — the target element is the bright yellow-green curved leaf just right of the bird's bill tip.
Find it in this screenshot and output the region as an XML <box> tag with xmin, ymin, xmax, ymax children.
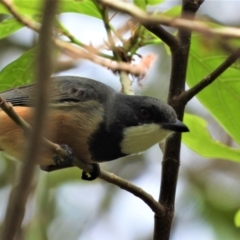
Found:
<box><xmin>182</xmin><ymin>114</ymin><xmax>240</xmax><ymax>162</ymax></box>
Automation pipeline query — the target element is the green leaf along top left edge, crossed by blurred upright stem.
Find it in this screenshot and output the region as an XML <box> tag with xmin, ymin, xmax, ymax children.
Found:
<box><xmin>0</xmin><ymin>0</ymin><xmax>101</xmax><ymax>18</ymax></box>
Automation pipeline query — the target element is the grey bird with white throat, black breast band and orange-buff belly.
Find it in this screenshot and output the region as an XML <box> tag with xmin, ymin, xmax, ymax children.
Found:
<box><xmin>0</xmin><ymin>76</ymin><xmax>189</xmax><ymax>177</ymax></box>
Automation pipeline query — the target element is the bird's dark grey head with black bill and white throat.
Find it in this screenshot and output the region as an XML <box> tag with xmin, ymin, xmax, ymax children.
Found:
<box><xmin>115</xmin><ymin>95</ymin><xmax>189</xmax><ymax>154</ymax></box>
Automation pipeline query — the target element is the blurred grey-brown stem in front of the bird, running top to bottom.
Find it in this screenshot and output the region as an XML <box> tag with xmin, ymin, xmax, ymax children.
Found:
<box><xmin>1</xmin><ymin>0</ymin><xmax>57</xmax><ymax>240</ymax></box>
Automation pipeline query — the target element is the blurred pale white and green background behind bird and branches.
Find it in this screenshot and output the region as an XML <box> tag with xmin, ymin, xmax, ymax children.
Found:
<box><xmin>0</xmin><ymin>0</ymin><xmax>240</xmax><ymax>240</ymax></box>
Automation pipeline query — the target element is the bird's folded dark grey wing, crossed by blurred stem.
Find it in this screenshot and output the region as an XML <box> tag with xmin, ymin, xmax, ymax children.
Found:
<box><xmin>0</xmin><ymin>76</ymin><xmax>114</xmax><ymax>106</ymax></box>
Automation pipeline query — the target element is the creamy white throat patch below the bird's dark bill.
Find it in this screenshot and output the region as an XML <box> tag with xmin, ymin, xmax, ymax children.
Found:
<box><xmin>121</xmin><ymin>123</ymin><xmax>172</xmax><ymax>154</ymax></box>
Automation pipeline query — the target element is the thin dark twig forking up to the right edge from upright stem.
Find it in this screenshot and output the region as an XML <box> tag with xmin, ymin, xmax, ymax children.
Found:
<box><xmin>178</xmin><ymin>48</ymin><xmax>240</xmax><ymax>104</ymax></box>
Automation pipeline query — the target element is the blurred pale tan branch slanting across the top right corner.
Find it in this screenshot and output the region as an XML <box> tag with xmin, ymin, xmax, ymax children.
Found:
<box><xmin>98</xmin><ymin>0</ymin><xmax>240</xmax><ymax>38</ymax></box>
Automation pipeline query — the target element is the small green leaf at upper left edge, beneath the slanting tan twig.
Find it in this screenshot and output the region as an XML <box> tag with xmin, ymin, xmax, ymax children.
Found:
<box><xmin>0</xmin><ymin>18</ymin><xmax>23</xmax><ymax>39</ymax></box>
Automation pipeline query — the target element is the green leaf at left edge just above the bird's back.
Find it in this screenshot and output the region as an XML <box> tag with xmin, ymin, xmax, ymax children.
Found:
<box><xmin>0</xmin><ymin>48</ymin><xmax>36</xmax><ymax>91</ymax></box>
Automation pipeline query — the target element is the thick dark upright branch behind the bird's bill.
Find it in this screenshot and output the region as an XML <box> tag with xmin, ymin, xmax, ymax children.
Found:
<box><xmin>154</xmin><ymin>0</ymin><xmax>202</xmax><ymax>240</ymax></box>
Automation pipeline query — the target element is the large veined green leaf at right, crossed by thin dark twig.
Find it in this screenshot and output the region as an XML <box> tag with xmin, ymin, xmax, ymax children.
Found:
<box><xmin>187</xmin><ymin>35</ymin><xmax>240</xmax><ymax>143</ymax></box>
